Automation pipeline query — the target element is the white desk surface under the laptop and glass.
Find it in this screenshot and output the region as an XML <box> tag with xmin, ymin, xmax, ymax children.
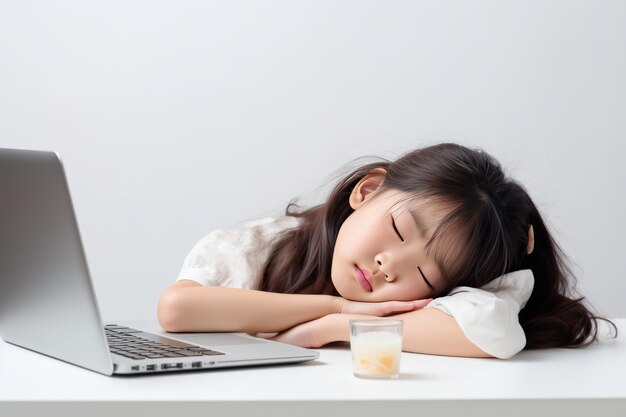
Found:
<box><xmin>0</xmin><ymin>319</ymin><xmax>626</xmax><ymax>417</ymax></box>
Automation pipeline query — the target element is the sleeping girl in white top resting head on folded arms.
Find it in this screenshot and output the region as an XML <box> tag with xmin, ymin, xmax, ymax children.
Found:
<box><xmin>158</xmin><ymin>144</ymin><xmax>616</xmax><ymax>358</ymax></box>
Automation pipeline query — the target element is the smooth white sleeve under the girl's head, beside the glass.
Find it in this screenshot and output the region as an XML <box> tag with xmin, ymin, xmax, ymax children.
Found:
<box><xmin>428</xmin><ymin>269</ymin><xmax>534</xmax><ymax>359</ymax></box>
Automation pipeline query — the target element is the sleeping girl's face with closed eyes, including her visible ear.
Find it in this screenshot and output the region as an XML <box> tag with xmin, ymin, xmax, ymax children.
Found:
<box><xmin>331</xmin><ymin>183</ymin><xmax>444</xmax><ymax>301</ymax></box>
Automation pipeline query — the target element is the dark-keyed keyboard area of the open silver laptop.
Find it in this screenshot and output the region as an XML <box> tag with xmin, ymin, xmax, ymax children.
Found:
<box><xmin>104</xmin><ymin>324</ymin><xmax>224</xmax><ymax>359</ymax></box>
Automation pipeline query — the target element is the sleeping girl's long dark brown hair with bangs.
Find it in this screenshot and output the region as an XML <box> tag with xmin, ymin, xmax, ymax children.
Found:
<box><xmin>261</xmin><ymin>143</ymin><xmax>617</xmax><ymax>348</ymax></box>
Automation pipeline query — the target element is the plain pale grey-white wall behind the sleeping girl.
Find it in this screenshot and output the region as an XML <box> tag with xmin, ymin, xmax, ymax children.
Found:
<box><xmin>0</xmin><ymin>0</ymin><xmax>626</xmax><ymax>319</ymax></box>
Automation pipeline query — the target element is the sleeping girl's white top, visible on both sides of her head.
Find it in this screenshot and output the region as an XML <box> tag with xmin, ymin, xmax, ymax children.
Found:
<box><xmin>177</xmin><ymin>216</ymin><xmax>534</xmax><ymax>359</ymax></box>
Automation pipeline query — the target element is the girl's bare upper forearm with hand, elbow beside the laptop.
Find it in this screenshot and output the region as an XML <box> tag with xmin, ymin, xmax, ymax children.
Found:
<box><xmin>158</xmin><ymin>280</ymin><xmax>429</xmax><ymax>333</ymax></box>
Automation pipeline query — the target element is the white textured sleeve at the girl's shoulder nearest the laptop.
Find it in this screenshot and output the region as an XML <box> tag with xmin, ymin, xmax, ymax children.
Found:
<box><xmin>177</xmin><ymin>217</ymin><xmax>297</xmax><ymax>289</ymax></box>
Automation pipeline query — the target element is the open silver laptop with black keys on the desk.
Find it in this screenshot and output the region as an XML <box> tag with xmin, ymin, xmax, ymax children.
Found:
<box><xmin>0</xmin><ymin>149</ymin><xmax>319</xmax><ymax>375</ymax></box>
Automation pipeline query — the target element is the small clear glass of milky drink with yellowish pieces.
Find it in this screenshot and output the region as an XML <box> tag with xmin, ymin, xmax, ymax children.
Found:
<box><xmin>350</xmin><ymin>319</ymin><xmax>403</xmax><ymax>379</ymax></box>
